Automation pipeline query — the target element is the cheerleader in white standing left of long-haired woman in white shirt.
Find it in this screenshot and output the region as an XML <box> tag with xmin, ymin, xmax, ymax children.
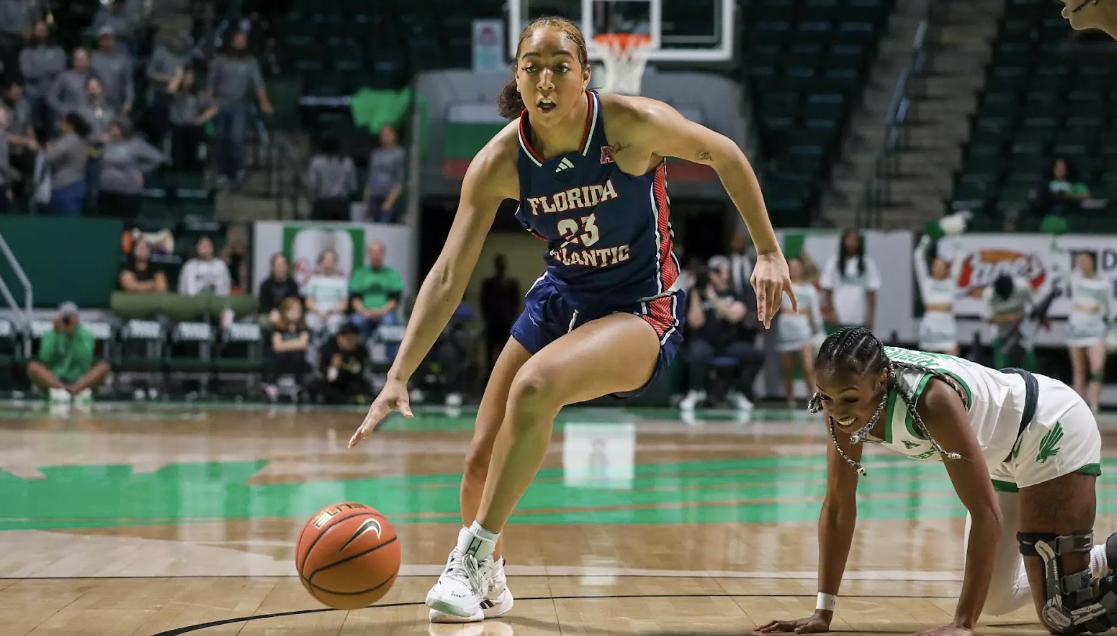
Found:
<box><xmin>776</xmin><ymin>258</ymin><xmax>823</xmax><ymax>409</ymax></box>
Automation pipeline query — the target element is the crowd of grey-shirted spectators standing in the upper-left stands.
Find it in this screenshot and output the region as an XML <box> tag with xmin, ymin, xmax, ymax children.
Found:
<box><xmin>0</xmin><ymin>0</ymin><xmax>271</xmax><ymax>218</ymax></box>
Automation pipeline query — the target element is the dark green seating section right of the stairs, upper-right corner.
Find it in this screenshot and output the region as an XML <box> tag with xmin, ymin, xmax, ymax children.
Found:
<box><xmin>952</xmin><ymin>0</ymin><xmax>1117</xmax><ymax>232</ymax></box>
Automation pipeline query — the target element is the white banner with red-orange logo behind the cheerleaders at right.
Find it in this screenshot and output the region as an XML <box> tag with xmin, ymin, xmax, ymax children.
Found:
<box><xmin>939</xmin><ymin>234</ymin><xmax>1117</xmax><ymax>319</ymax></box>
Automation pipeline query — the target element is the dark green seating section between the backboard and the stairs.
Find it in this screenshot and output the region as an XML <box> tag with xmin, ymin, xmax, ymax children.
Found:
<box><xmin>738</xmin><ymin>0</ymin><xmax>892</xmax><ymax>225</ymax></box>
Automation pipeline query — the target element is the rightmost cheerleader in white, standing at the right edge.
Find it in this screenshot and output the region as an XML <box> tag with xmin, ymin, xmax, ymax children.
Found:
<box><xmin>1052</xmin><ymin>241</ymin><xmax>1113</xmax><ymax>412</ymax></box>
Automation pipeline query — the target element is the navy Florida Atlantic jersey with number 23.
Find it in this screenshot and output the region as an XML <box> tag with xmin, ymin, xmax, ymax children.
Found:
<box><xmin>516</xmin><ymin>91</ymin><xmax>679</xmax><ymax>306</ymax></box>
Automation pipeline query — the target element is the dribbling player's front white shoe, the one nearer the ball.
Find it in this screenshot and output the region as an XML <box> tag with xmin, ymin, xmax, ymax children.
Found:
<box><xmin>427</xmin><ymin>528</ymin><xmax>507</xmax><ymax>623</ymax></box>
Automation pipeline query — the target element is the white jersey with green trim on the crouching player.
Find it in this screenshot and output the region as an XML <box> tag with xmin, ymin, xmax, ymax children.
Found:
<box><xmin>882</xmin><ymin>347</ymin><xmax>1025</xmax><ymax>466</ymax></box>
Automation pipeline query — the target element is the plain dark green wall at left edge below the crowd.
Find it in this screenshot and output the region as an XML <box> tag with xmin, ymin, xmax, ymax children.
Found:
<box><xmin>0</xmin><ymin>216</ymin><xmax>123</xmax><ymax>308</ymax></box>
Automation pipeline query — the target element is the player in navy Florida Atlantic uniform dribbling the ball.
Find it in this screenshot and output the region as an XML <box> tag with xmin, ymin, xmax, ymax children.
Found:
<box><xmin>350</xmin><ymin>18</ymin><xmax>796</xmax><ymax>623</ymax></box>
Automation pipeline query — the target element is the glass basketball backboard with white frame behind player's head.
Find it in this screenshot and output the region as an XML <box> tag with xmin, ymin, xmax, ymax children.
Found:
<box><xmin>508</xmin><ymin>0</ymin><xmax>736</xmax><ymax>64</ymax></box>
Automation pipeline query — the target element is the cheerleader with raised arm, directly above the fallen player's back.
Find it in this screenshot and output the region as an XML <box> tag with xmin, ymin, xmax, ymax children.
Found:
<box><xmin>911</xmin><ymin>235</ymin><xmax>961</xmax><ymax>355</ymax></box>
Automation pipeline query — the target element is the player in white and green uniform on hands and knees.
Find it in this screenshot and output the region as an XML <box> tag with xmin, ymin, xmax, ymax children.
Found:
<box><xmin>760</xmin><ymin>328</ymin><xmax>1117</xmax><ymax>636</ymax></box>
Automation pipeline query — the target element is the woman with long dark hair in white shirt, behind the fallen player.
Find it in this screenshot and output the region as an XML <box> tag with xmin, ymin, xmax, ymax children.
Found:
<box><xmin>819</xmin><ymin>229</ymin><xmax>880</xmax><ymax>331</ymax></box>
